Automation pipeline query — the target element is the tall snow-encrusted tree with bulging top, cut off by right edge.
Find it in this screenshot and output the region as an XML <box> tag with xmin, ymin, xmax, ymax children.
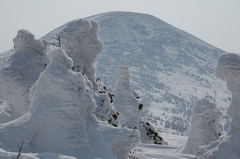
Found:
<box><xmin>201</xmin><ymin>53</ymin><xmax>240</xmax><ymax>159</ymax></box>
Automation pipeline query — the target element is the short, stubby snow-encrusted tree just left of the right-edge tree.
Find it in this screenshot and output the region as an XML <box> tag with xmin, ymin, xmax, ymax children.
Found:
<box><xmin>178</xmin><ymin>98</ymin><xmax>222</xmax><ymax>155</ymax></box>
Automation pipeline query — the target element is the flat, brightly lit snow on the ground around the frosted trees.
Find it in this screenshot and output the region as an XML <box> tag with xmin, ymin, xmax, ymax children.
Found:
<box><xmin>0</xmin><ymin>133</ymin><xmax>196</xmax><ymax>159</ymax></box>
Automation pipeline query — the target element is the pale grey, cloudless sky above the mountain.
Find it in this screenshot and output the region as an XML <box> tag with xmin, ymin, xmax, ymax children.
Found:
<box><xmin>0</xmin><ymin>0</ymin><xmax>240</xmax><ymax>53</ymax></box>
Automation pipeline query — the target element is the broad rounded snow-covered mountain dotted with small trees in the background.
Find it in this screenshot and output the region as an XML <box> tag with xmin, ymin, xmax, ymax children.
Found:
<box><xmin>36</xmin><ymin>12</ymin><xmax>231</xmax><ymax>133</ymax></box>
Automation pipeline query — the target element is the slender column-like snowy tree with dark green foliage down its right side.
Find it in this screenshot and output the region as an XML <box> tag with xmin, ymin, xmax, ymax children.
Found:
<box><xmin>113</xmin><ymin>66</ymin><xmax>167</xmax><ymax>144</ymax></box>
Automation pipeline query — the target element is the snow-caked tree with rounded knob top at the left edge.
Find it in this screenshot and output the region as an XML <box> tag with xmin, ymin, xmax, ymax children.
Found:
<box><xmin>0</xmin><ymin>30</ymin><xmax>48</xmax><ymax>123</ymax></box>
